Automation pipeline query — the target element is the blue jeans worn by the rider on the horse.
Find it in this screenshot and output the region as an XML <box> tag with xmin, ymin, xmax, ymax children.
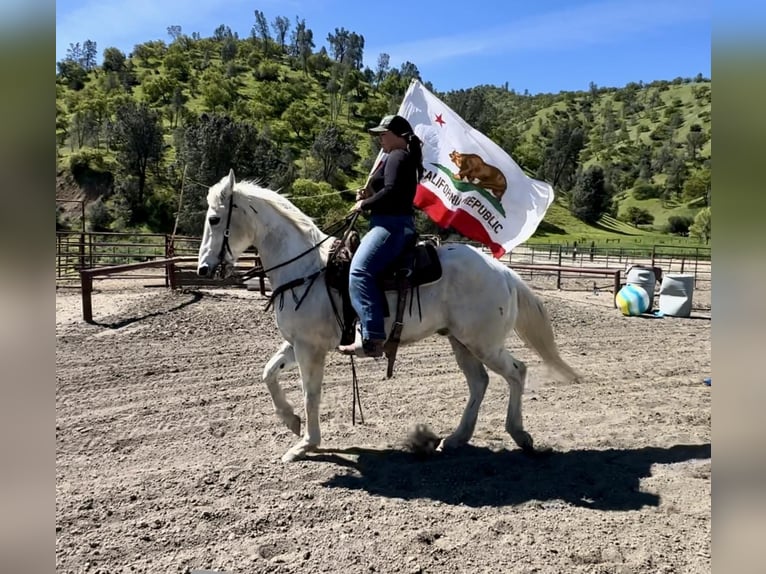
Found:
<box><xmin>349</xmin><ymin>215</ymin><xmax>415</xmax><ymax>339</ymax></box>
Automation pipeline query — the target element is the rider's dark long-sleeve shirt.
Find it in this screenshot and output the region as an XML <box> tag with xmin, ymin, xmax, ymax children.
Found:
<box><xmin>362</xmin><ymin>149</ymin><xmax>418</xmax><ymax>215</ymax></box>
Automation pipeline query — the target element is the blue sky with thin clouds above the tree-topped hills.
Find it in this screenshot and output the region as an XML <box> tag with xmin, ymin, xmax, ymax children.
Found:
<box><xmin>56</xmin><ymin>0</ymin><xmax>713</xmax><ymax>94</ymax></box>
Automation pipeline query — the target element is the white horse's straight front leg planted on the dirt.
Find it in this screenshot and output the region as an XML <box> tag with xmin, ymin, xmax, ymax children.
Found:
<box><xmin>282</xmin><ymin>343</ymin><xmax>327</xmax><ymax>462</ymax></box>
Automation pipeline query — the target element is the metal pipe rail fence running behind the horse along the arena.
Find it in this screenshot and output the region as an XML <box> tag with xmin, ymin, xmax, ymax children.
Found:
<box><xmin>56</xmin><ymin>231</ymin><xmax>712</xmax><ymax>320</ymax></box>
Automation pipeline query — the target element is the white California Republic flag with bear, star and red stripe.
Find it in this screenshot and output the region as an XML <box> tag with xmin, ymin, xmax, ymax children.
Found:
<box><xmin>398</xmin><ymin>80</ymin><xmax>553</xmax><ymax>257</ymax></box>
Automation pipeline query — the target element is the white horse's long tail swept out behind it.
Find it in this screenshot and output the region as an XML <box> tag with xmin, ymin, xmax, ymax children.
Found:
<box><xmin>509</xmin><ymin>270</ymin><xmax>580</xmax><ymax>381</ymax></box>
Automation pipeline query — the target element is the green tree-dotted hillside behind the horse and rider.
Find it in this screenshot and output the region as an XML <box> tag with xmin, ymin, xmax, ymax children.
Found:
<box><xmin>56</xmin><ymin>18</ymin><xmax>711</xmax><ymax>245</ymax></box>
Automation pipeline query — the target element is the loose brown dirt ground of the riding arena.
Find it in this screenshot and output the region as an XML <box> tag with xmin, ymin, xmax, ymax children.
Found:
<box><xmin>56</xmin><ymin>280</ymin><xmax>711</xmax><ymax>574</ymax></box>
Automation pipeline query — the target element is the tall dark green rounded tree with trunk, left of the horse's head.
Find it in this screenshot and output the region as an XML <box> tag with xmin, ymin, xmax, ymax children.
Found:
<box><xmin>110</xmin><ymin>100</ymin><xmax>164</xmax><ymax>218</ymax></box>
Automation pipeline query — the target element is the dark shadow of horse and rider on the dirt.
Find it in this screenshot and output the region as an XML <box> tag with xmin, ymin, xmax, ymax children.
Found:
<box><xmin>311</xmin><ymin>443</ymin><xmax>711</xmax><ymax>510</ymax></box>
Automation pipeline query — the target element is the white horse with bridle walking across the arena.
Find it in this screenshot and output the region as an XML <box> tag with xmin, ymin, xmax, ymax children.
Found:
<box><xmin>197</xmin><ymin>171</ymin><xmax>578</xmax><ymax>462</ymax></box>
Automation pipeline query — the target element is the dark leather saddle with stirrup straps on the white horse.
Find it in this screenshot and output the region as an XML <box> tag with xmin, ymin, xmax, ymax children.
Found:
<box><xmin>327</xmin><ymin>231</ymin><xmax>442</xmax><ymax>378</ymax></box>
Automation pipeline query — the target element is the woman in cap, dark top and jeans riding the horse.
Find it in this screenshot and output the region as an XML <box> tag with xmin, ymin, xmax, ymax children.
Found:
<box><xmin>338</xmin><ymin>115</ymin><xmax>423</xmax><ymax>357</ymax></box>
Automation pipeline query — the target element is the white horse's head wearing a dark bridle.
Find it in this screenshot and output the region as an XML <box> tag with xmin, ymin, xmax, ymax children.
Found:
<box><xmin>197</xmin><ymin>170</ymin><xmax>253</xmax><ymax>277</ymax></box>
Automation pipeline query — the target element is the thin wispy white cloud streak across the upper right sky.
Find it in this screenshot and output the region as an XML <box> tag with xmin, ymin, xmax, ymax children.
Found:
<box><xmin>368</xmin><ymin>0</ymin><xmax>711</xmax><ymax>65</ymax></box>
